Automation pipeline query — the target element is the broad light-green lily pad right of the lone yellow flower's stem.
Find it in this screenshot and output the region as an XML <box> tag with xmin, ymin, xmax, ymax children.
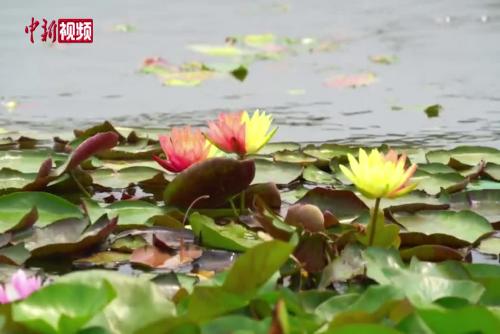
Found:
<box><xmin>395</xmin><ymin>210</ymin><xmax>493</xmax><ymax>243</ymax></box>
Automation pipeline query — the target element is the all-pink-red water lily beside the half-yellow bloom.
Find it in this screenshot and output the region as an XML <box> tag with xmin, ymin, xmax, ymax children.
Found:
<box><xmin>153</xmin><ymin>126</ymin><xmax>216</xmax><ymax>173</ymax></box>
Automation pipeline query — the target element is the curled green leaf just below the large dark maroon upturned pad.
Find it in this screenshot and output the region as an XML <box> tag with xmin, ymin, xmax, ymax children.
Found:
<box><xmin>189</xmin><ymin>212</ymin><xmax>262</xmax><ymax>252</ymax></box>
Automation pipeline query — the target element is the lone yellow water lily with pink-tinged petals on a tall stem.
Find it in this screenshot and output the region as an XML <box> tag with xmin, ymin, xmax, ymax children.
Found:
<box><xmin>340</xmin><ymin>149</ymin><xmax>417</xmax><ymax>198</ymax></box>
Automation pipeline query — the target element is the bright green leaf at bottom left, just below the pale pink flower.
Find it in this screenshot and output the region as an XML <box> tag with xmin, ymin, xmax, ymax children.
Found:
<box><xmin>12</xmin><ymin>281</ymin><xmax>116</xmax><ymax>334</ymax></box>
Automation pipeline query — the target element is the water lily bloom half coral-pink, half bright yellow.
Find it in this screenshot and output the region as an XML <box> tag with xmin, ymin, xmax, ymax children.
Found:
<box><xmin>207</xmin><ymin>110</ymin><xmax>278</xmax><ymax>156</ymax></box>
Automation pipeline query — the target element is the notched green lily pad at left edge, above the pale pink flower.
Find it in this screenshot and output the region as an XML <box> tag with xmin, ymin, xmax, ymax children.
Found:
<box><xmin>0</xmin><ymin>192</ymin><xmax>83</xmax><ymax>231</ymax></box>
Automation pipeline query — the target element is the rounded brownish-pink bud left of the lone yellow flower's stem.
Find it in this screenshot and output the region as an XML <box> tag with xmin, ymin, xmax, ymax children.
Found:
<box><xmin>285</xmin><ymin>204</ymin><xmax>325</xmax><ymax>232</ymax></box>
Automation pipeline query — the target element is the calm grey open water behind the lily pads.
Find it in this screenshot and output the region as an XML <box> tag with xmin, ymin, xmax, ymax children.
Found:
<box><xmin>0</xmin><ymin>0</ymin><xmax>500</xmax><ymax>147</ymax></box>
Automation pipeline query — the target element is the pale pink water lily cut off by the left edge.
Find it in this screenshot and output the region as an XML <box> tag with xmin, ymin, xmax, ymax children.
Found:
<box><xmin>0</xmin><ymin>269</ymin><xmax>42</xmax><ymax>304</ymax></box>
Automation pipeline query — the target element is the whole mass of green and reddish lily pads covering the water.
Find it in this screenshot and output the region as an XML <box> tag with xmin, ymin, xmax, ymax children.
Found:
<box><xmin>0</xmin><ymin>122</ymin><xmax>500</xmax><ymax>333</ymax></box>
